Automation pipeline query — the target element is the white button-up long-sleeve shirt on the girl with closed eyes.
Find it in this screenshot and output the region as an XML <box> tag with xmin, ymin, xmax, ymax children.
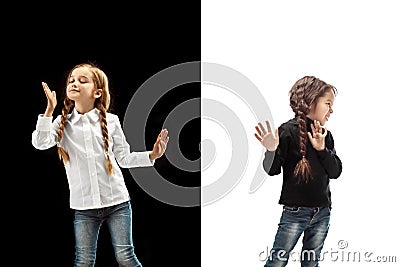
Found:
<box><xmin>32</xmin><ymin>109</ymin><xmax>154</xmax><ymax>210</ymax></box>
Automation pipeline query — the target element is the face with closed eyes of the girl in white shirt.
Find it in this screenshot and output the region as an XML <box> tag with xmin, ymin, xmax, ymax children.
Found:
<box><xmin>67</xmin><ymin>67</ymin><xmax>101</xmax><ymax>106</ymax></box>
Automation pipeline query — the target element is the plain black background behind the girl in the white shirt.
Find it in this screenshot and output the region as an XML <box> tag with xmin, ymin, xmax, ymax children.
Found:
<box><xmin>8</xmin><ymin>1</ymin><xmax>201</xmax><ymax>267</ymax></box>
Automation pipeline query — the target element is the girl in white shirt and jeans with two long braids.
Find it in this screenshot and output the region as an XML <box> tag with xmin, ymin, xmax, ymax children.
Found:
<box><xmin>32</xmin><ymin>64</ymin><xmax>169</xmax><ymax>267</ymax></box>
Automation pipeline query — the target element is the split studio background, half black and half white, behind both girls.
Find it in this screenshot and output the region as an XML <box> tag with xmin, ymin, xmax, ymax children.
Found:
<box><xmin>1</xmin><ymin>0</ymin><xmax>400</xmax><ymax>267</ymax></box>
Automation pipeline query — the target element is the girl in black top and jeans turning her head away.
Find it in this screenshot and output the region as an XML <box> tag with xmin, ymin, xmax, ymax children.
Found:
<box><xmin>255</xmin><ymin>76</ymin><xmax>342</xmax><ymax>267</ymax></box>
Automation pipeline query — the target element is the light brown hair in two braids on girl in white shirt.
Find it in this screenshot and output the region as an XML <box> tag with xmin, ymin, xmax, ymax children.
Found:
<box><xmin>57</xmin><ymin>63</ymin><xmax>113</xmax><ymax>175</ymax></box>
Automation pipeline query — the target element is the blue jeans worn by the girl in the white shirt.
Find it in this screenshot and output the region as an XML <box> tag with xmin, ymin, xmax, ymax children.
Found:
<box><xmin>74</xmin><ymin>201</ymin><xmax>142</xmax><ymax>267</ymax></box>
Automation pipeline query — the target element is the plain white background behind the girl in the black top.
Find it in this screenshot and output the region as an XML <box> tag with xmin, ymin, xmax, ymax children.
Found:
<box><xmin>201</xmin><ymin>0</ymin><xmax>400</xmax><ymax>267</ymax></box>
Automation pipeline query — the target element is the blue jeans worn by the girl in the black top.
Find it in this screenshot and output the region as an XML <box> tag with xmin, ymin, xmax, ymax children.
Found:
<box><xmin>264</xmin><ymin>206</ymin><xmax>331</xmax><ymax>267</ymax></box>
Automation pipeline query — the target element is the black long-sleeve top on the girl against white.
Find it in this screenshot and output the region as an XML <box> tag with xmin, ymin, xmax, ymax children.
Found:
<box><xmin>263</xmin><ymin>118</ymin><xmax>342</xmax><ymax>207</ymax></box>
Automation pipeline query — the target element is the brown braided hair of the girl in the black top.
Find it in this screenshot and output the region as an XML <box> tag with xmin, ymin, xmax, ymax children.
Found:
<box><xmin>289</xmin><ymin>76</ymin><xmax>337</xmax><ymax>183</ymax></box>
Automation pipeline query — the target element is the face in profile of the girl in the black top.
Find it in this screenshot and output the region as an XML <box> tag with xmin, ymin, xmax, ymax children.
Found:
<box><xmin>307</xmin><ymin>90</ymin><xmax>335</xmax><ymax>125</ymax></box>
